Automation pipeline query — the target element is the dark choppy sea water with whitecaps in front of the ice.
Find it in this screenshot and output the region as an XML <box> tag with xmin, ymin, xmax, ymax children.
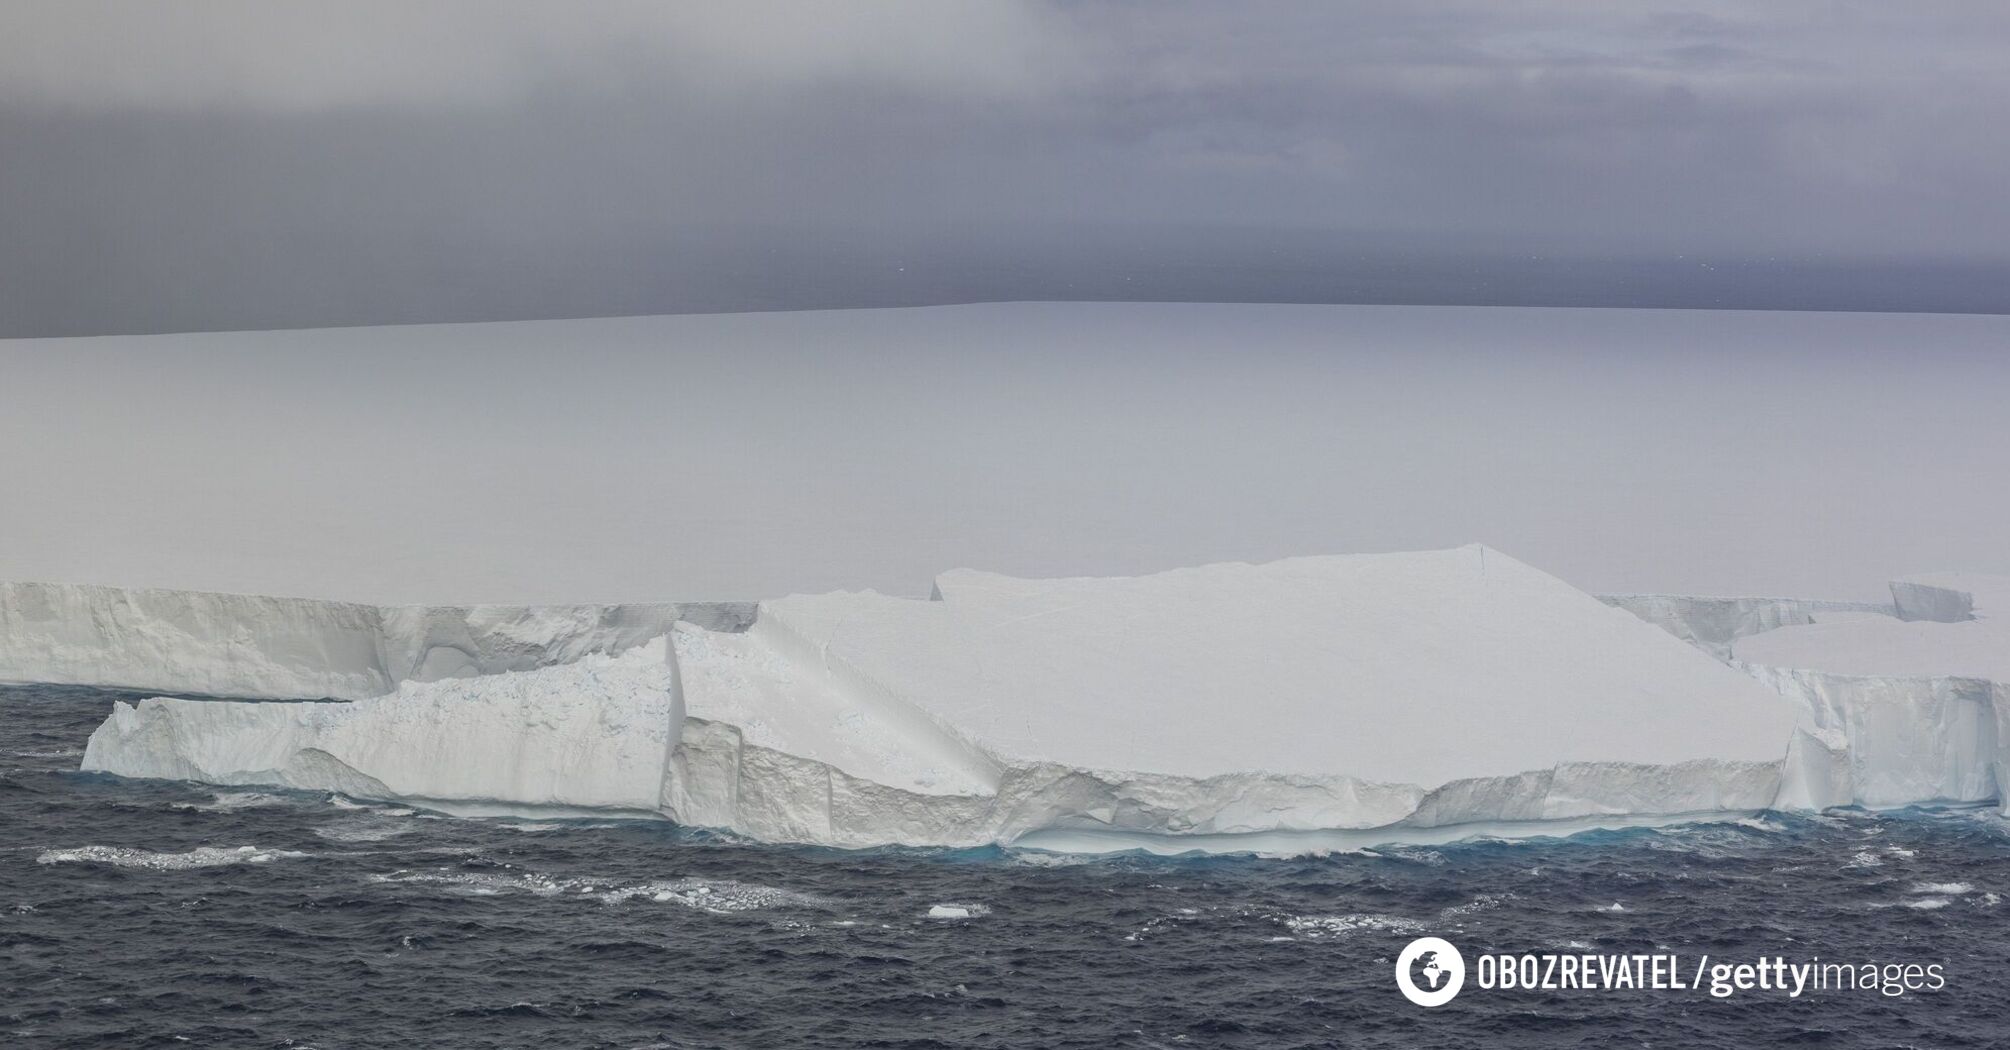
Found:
<box><xmin>0</xmin><ymin>688</ymin><xmax>2010</xmax><ymax>1050</ymax></box>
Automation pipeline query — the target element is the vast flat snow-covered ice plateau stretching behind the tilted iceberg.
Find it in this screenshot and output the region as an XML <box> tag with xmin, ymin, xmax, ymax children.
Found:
<box><xmin>0</xmin><ymin>304</ymin><xmax>2010</xmax><ymax>601</ymax></box>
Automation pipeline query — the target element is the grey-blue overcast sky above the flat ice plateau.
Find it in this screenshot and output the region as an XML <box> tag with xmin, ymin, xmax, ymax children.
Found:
<box><xmin>11</xmin><ymin>0</ymin><xmax>2010</xmax><ymax>334</ymax></box>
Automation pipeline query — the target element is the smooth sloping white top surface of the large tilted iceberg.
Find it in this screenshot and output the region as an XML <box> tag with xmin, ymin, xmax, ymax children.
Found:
<box><xmin>760</xmin><ymin>547</ymin><xmax>1793</xmax><ymax>786</ymax></box>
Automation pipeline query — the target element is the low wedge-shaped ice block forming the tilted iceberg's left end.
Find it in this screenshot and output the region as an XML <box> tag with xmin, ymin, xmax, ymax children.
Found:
<box><xmin>82</xmin><ymin>640</ymin><xmax>683</xmax><ymax>811</ymax></box>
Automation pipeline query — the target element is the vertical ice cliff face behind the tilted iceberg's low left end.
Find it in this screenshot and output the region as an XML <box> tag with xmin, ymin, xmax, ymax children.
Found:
<box><xmin>0</xmin><ymin>583</ymin><xmax>752</xmax><ymax>700</ymax></box>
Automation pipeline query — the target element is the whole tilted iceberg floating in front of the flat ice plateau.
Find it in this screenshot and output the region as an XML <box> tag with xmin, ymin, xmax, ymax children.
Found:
<box><xmin>84</xmin><ymin>547</ymin><xmax>1795</xmax><ymax>851</ymax></box>
